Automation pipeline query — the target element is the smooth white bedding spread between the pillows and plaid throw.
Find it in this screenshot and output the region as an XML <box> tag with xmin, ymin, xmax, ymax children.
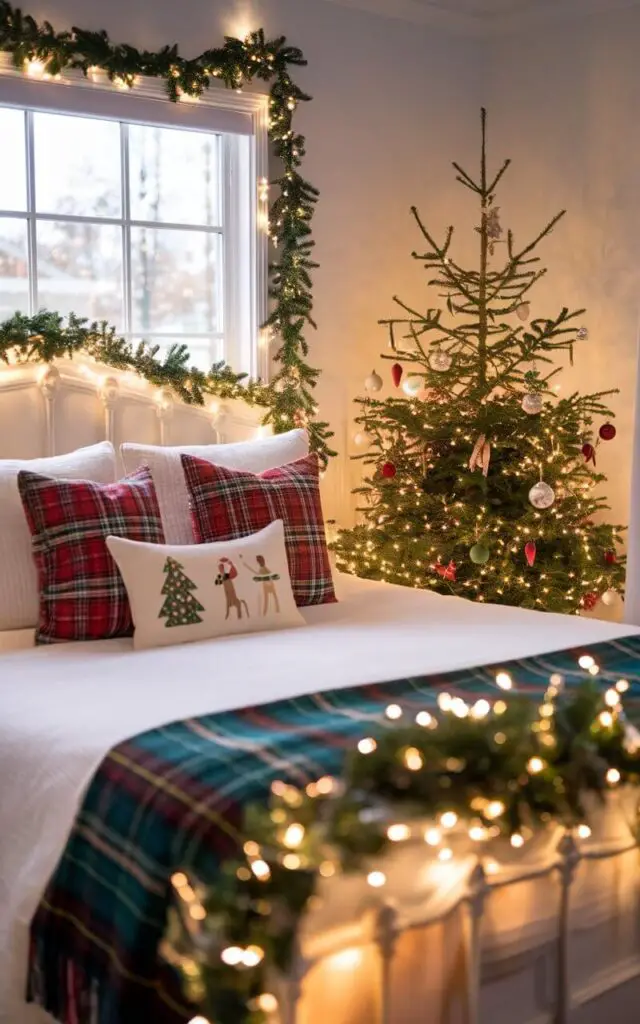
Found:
<box><xmin>0</xmin><ymin>577</ymin><xmax>640</xmax><ymax>1024</ymax></box>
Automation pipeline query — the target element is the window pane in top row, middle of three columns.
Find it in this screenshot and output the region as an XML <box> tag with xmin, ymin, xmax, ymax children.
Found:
<box><xmin>34</xmin><ymin>114</ymin><xmax>121</xmax><ymax>217</ymax></box>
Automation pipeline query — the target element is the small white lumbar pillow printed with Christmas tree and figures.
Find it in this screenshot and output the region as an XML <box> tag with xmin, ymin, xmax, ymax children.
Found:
<box><xmin>106</xmin><ymin>519</ymin><xmax>304</xmax><ymax>651</ymax></box>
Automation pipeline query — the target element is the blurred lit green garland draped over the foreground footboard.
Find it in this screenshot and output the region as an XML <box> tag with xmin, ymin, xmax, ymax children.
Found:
<box><xmin>162</xmin><ymin>671</ymin><xmax>640</xmax><ymax>1024</ymax></box>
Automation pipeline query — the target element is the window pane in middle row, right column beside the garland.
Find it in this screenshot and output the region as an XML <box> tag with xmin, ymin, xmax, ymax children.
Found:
<box><xmin>131</xmin><ymin>227</ymin><xmax>221</xmax><ymax>334</ymax></box>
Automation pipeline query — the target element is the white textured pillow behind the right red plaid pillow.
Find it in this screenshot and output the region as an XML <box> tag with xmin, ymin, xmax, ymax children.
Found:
<box><xmin>120</xmin><ymin>430</ymin><xmax>309</xmax><ymax>544</ymax></box>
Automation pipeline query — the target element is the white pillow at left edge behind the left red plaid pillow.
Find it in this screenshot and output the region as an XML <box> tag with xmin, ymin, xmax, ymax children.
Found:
<box><xmin>0</xmin><ymin>441</ymin><xmax>118</xmax><ymax>630</ymax></box>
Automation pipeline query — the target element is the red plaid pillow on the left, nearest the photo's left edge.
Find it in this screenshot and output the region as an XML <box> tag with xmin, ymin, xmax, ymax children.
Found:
<box><xmin>17</xmin><ymin>468</ymin><xmax>164</xmax><ymax>643</ymax></box>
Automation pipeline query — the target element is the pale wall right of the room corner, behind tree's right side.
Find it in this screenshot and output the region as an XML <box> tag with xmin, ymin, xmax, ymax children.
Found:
<box><xmin>485</xmin><ymin>4</ymin><xmax>640</xmax><ymax>536</ymax></box>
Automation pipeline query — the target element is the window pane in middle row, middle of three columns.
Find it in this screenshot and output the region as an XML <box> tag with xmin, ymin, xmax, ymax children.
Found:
<box><xmin>37</xmin><ymin>220</ymin><xmax>124</xmax><ymax>330</ymax></box>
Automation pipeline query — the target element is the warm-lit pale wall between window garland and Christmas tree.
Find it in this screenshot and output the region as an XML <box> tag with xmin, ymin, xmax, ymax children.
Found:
<box><xmin>25</xmin><ymin>0</ymin><xmax>479</xmax><ymax>521</ymax></box>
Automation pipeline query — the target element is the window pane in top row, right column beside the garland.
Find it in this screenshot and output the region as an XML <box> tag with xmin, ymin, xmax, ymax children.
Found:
<box><xmin>129</xmin><ymin>125</ymin><xmax>220</xmax><ymax>227</ymax></box>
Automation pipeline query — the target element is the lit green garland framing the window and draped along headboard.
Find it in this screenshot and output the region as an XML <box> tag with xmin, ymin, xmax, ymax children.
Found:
<box><xmin>0</xmin><ymin>0</ymin><xmax>335</xmax><ymax>464</ymax></box>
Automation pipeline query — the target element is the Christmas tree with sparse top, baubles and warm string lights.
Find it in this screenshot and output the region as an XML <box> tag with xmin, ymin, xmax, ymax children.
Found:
<box><xmin>334</xmin><ymin>111</ymin><xmax>624</xmax><ymax>612</ymax></box>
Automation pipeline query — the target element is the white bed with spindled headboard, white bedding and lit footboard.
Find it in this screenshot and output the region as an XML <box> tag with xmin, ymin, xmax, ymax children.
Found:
<box><xmin>0</xmin><ymin>356</ymin><xmax>640</xmax><ymax>1024</ymax></box>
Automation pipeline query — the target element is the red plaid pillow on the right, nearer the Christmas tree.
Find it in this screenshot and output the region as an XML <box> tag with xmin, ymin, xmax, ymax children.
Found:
<box><xmin>181</xmin><ymin>455</ymin><xmax>336</xmax><ymax>605</ymax></box>
